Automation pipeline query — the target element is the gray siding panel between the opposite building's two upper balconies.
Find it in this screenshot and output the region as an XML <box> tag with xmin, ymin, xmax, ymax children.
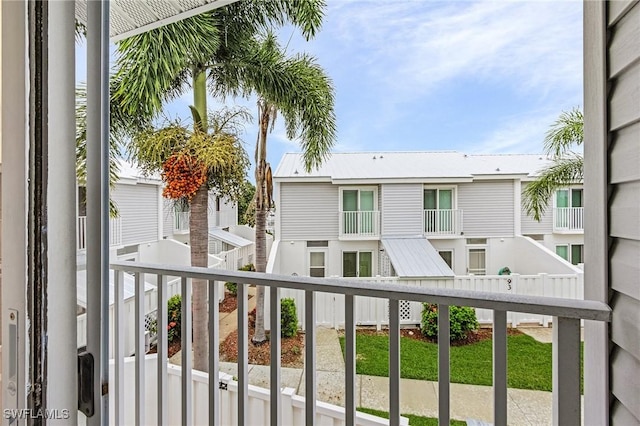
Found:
<box><xmin>380</xmin><ymin>184</ymin><xmax>424</xmax><ymax>235</ymax></box>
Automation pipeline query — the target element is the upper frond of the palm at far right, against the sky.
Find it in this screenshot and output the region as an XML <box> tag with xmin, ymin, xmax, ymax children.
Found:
<box><xmin>544</xmin><ymin>107</ymin><xmax>584</xmax><ymax>157</ymax></box>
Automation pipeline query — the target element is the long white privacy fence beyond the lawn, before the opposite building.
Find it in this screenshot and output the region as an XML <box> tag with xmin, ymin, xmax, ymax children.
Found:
<box><xmin>272</xmin><ymin>274</ymin><xmax>584</xmax><ymax>329</ymax></box>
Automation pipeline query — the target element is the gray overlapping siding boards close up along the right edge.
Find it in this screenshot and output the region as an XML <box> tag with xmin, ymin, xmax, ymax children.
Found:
<box><xmin>606</xmin><ymin>2</ymin><xmax>640</xmax><ymax>425</ymax></box>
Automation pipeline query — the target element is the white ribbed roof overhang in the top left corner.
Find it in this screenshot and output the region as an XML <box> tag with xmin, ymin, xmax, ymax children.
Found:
<box><xmin>76</xmin><ymin>0</ymin><xmax>236</xmax><ymax>41</ymax></box>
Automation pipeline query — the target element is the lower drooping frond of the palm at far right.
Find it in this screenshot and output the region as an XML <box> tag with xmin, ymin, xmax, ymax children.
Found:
<box><xmin>522</xmin><ymin>154</ymin><xmax>584</xmax><ymax>221</ymax></box>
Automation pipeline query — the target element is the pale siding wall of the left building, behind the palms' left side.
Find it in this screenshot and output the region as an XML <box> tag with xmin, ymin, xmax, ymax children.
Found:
<box><xmin>111</xmin><ymin>183</ymin><xmax>159</xmax><ymax>245</ymax></box>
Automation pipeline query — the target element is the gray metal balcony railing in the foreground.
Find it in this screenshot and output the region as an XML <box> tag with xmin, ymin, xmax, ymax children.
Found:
<box><xmin>109</xmin><ymin>262</ymin><xmax>611</xmax><ymax>425</ymax></box>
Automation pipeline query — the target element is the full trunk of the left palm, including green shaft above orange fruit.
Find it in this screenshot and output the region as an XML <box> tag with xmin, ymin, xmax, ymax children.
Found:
<box><xmin>190</xmin><ymin>71</ymin><xmax>210</xmax><ymax>372</ymax></box>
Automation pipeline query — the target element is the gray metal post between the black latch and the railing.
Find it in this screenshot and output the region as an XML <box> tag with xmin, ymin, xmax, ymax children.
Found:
<box><xmin>87</xmin><ymin>0</ymin><xmax>109</xmax><ymax>426</ymax></box>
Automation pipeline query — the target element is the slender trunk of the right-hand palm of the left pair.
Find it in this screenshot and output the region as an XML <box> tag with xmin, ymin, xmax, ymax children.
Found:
<box><xmin>252</xmin><ymin>101</ymin><xmax>271</xmax><ymax>343</ymax></box>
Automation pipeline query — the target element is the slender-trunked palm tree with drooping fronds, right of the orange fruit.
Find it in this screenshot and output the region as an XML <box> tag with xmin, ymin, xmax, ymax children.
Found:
<box><xmin>220</xmin><ymin>34</ymin><xmax>336</xmax><ymax>343</ymax></box>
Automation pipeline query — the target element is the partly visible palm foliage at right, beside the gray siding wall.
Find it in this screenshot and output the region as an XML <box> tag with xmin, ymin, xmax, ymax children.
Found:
<box><xmin>522</xmin><ymin>108</ymin><xmax>584</xmax><ymax>221</ymax></box>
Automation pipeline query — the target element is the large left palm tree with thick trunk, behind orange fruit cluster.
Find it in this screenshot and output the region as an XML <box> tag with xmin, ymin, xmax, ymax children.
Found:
<box><xmin>111</xmin><ymin>0</ymin><xmax>325</xmax><ymax>371</ymax></box>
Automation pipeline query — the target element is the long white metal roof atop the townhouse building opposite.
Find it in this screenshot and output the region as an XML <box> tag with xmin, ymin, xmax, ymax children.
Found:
<box><xmin>274</xmin><ymin>151</ymin><xmax>552</xmax><ymax>180</ymax></box>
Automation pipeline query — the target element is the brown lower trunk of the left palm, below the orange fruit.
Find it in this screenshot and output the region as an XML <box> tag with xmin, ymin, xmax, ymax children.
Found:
<box><xmin>190</xmin><ymin>184</ymin><xmax>210</xmax><ymax>372</ymax></box>
